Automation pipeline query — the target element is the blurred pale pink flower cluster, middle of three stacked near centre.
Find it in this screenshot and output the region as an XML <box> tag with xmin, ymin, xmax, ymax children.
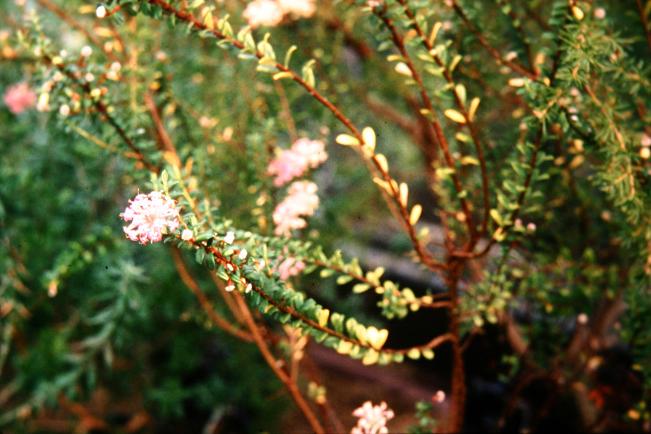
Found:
<box><xmin>273</xmin><ymin>181</ymin><xmax>319</xmax><ymax>236</ymax></box>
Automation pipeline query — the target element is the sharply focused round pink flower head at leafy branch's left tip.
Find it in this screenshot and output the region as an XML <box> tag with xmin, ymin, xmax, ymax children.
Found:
<box><xmin>120</xmin><ymin>191</ymin><xmax>179</xmax><ymax>245</ymax></box>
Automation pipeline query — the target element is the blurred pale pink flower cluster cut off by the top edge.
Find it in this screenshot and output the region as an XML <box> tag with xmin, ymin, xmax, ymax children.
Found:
<box><xmin>243</xmin><ymin>0</ymin><xmax>316</xmax><ymax>28</ymax></box>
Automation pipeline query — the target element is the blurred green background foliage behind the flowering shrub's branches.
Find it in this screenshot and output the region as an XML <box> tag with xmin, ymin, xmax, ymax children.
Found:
<box><xmin>0</xmin><ymin>0</ymin><xmax>651</xmax><ymax>433</ymax></box>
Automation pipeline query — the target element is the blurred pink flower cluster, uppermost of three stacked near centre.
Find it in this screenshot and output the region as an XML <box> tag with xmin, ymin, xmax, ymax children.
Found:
<box><xmin>267</xmin><ymin>139</ymin><xmax>328</xmax><ymax>187</ymax></box>
